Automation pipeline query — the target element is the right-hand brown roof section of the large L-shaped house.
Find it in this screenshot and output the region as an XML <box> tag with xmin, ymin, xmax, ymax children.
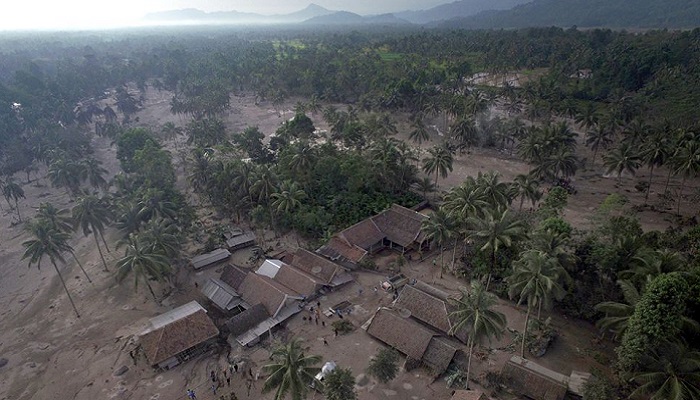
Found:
<box><xmin>371</xmin><ymin>204</ymin><xmax>428</xmax><ymax>247</ymax></box>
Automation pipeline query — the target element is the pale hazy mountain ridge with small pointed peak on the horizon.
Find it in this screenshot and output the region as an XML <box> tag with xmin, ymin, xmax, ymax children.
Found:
<box><xmin>143</xmin><ymin>3</ymin><xmax>335</xmax><ymax>23</ymax></box>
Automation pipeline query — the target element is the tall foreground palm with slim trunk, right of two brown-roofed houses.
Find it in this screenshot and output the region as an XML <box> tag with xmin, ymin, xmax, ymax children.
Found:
<box><xmin>449</xmin><ymin>281</ymin><xmax>506</xmax><ymax>388</ymax></box>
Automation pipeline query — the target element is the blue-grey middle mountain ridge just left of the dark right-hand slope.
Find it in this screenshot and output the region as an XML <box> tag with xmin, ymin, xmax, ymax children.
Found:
<box><xmin>395</xmin><ymin>0</ymin><xmax>532</xmax><ymax>24</ymax></box>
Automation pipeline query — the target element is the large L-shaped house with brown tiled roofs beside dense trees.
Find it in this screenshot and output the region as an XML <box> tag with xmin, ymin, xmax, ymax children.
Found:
<box><xmin>318</xmin><ymin>204</ymin><xmax>429</xmax><ymax>264</ymax></box>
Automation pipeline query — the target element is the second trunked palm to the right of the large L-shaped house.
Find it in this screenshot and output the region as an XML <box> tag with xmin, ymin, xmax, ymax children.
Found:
<box><xmin>467</xmin><ymin>208</ymin><xmax>527</xmax><ymax>290</ymax></box>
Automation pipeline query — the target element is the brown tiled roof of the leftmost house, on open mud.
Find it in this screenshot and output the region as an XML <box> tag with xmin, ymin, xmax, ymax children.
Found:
<box><xmin>140</xmin><ymin>310</ymin><xmax>219</xmax><ymax>365</ymax></box>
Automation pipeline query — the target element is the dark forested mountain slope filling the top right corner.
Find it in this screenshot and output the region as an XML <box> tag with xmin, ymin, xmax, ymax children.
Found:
<box><xmin>435</xmin><ymin>0</ymin><xmax>700</xmax><ymax>29</ymax></box>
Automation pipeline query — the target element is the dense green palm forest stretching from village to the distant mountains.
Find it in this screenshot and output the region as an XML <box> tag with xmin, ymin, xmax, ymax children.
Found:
<box><xmin>0</xmin><ymin>28</ymin><xmax>700</xmax><ymax>399</ymax></box>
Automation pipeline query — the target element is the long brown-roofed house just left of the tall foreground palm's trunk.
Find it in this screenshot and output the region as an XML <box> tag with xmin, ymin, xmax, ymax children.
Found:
<box><xmin>367</xmin><ymin>308</ymin><xmax>459</xmax><ymax>376</ymax></box>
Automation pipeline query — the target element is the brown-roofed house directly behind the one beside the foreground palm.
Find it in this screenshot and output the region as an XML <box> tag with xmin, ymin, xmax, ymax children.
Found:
<box><xmin>395</xmin><ymin>281</ymin><xmax>468</xmax><ymax>343</ymax></box>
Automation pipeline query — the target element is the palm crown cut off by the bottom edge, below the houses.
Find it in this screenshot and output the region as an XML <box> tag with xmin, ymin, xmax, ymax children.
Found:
<box><xmin>262</xmin><ymin>340</ymin><xmax>321</xmax><ymax>400</ymax></box>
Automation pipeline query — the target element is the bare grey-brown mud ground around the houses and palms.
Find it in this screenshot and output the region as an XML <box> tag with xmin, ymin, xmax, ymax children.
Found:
<box><xmin>0</xmin><ymin>89</ymin><xmax>698</xmax><ymax>400</ymax></box>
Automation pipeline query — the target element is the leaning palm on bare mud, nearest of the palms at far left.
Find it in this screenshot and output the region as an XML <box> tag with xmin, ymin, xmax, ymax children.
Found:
<box><xmin>22</xmin><ymin>221</ymin><xmax>80</xmax><ymax>318</ymax></box>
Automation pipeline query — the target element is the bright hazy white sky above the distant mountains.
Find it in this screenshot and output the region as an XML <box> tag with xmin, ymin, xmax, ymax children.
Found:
<box><xmin>0</xmin><ymin>0</ymin><xmax>454</xmax><ymax>30</ymax></box>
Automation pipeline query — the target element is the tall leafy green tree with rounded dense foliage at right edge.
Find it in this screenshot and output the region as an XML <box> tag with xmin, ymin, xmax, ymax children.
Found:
<box><xmin>616</xmin><ymin>273</ymin><xmax>690</xmax><ymax>371</ymax></box>
